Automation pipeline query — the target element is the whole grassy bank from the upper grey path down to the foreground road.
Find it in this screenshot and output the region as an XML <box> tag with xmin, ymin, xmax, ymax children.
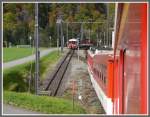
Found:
<box><xmin>3</xmin><ymin>51</ymin><xmax>85</xmax><ymax>114</ymax></box>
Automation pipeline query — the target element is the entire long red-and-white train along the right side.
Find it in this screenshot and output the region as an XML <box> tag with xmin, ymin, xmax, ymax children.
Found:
<box><xmin>87</xmin><ymin>3</ymin><xmax>148</xmax><ymax>114</ymax></box>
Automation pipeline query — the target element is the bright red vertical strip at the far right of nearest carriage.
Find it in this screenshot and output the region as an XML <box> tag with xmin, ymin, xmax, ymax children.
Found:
<box><xmin>140</xmin><ymin>4</ymin><xmax>148</xmax><ymax>114</ymax></box>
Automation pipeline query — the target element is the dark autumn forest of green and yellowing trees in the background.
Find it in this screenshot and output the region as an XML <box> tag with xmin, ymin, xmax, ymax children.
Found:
<box><xmin>3</xmin><ymin>3</ymin><xmax>115</xmax><ymax>47</ymax></box>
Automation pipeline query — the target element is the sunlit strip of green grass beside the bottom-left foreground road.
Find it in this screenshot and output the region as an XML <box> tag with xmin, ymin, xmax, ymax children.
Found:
<box><xmin>4</xmin><ymin>91</ymin><xmax>85</xmax><ymax>114</ymax></box>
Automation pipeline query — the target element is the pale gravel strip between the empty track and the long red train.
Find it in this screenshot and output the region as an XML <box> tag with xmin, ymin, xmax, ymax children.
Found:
<box><xmin>57</xmin><ymin>50</ymin><xmax>105</xmax><ymax>114</ymax></box>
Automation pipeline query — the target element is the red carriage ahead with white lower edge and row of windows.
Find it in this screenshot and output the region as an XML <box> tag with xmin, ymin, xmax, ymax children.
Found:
<box><xmin>87</xmin><ymin>50</ymin><xmax>113</xmax><ymax>114</ymax></box>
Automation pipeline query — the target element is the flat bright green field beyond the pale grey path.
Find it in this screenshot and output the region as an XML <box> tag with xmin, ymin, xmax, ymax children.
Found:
<box><xmin>3</xmin><ymin>47</ymin><xmax>35</xmax><ymax>62</ymax></box>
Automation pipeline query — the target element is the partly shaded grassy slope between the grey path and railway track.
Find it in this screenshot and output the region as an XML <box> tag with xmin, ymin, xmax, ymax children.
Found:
<box><xmin>3</xmin><ymin>51</ymin><xmax>61</xmax><ymax>91</ymax></box>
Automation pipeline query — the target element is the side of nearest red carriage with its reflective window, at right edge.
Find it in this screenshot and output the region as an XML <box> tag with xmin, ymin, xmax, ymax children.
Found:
<box><xmin>115</xmin><ymin>3</ymin><xmax>147</xmax><ymax>114</ymax></box>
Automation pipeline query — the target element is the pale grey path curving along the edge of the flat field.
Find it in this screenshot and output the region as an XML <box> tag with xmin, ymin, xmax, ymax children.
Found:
<box><xmin>3</xmin><ymin>48</ymin><xmax>57</xmax><ymax>69</ymax></box>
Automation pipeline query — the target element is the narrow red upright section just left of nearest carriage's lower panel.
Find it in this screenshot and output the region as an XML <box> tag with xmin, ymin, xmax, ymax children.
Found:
<box><xmin>114</xmin><ymin>50</ymin><xmax>125</xmax><ymax>114</ymax></box>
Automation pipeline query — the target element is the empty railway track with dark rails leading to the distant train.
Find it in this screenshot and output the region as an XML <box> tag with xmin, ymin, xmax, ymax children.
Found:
<box><xmin>44</xmin><ymin>50</ymin><xmax>74</xmax><ymax>96</ymax></box>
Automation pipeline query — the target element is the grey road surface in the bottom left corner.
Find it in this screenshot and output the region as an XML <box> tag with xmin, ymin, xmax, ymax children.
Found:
<box><xmin>3</xmin><ymin>104</ymin><xmax>42</xmax><ymax>114</ymax></box>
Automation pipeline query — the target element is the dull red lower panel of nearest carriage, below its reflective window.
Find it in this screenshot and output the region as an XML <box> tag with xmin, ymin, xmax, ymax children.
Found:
<box><xmin>122</xmin><ymin>47</ymin><xmax>141</xmax><ymax>114</ymax></box>
